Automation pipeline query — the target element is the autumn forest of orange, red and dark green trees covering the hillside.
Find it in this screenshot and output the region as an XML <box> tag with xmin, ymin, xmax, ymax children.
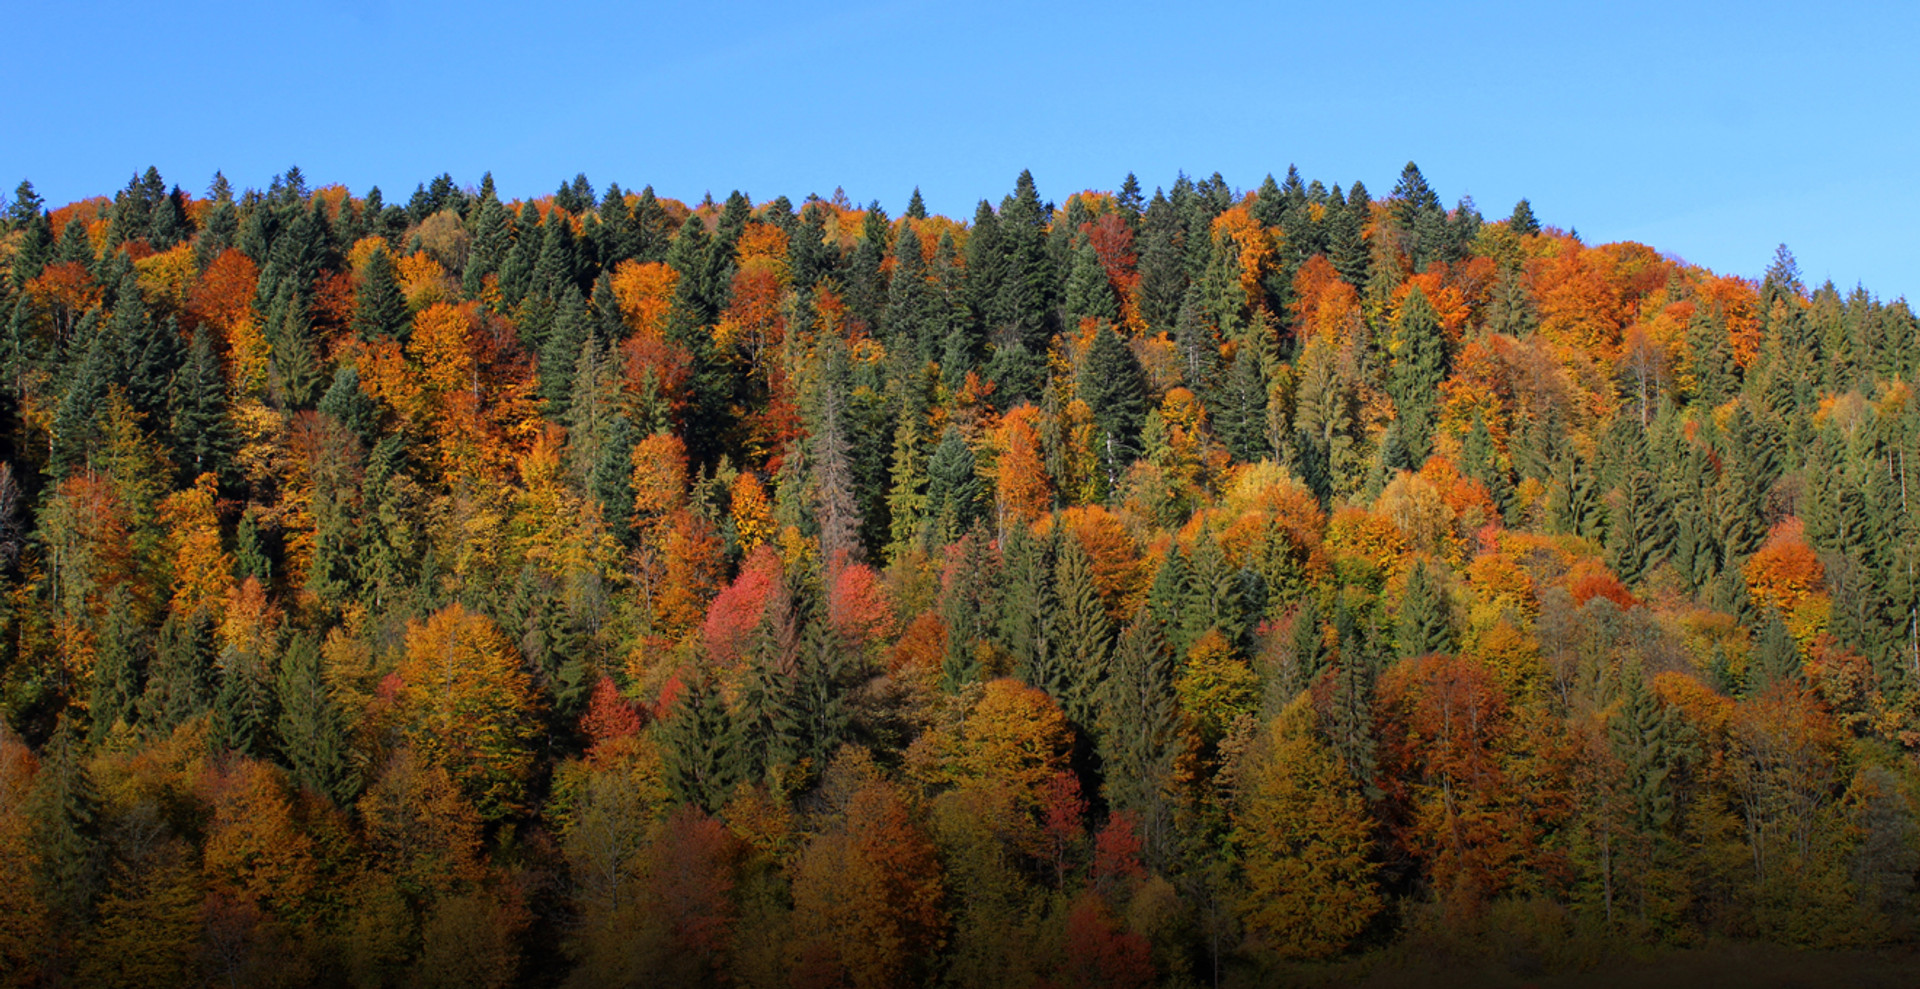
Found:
<box><xmin>0</xmin><ymin>163</ymin><xmax>1920</xmax><ymax>989</ymax></box>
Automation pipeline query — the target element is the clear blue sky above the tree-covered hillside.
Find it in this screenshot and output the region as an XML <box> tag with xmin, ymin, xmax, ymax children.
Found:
<box><xmin>0</xmin><ymin>0</ymin><xmax>1920</xmax><ymax>300</ymax></box>
